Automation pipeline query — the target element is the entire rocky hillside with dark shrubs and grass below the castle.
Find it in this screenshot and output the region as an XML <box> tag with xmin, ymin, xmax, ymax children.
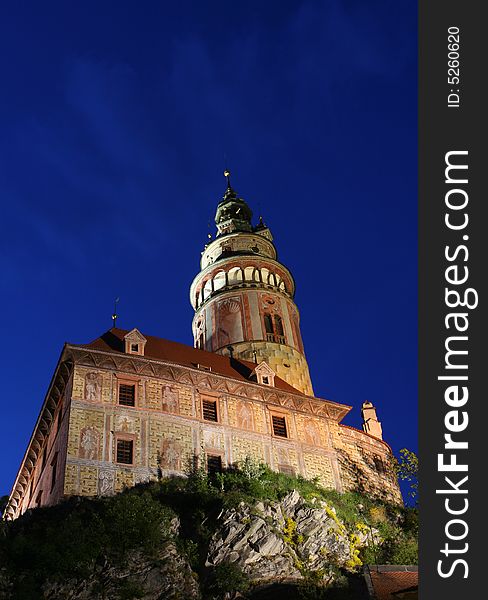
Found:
<box><xmin>0</xmin><ymin>471</ymin><xmax>420</xmax><ymax>600</ymax></box>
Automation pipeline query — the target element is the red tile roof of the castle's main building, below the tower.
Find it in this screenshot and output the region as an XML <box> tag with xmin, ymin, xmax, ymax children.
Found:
<box><xmin>73</xmin><ymin>328</ymin><xmax>304</xmax><ymax>396</ymax></box>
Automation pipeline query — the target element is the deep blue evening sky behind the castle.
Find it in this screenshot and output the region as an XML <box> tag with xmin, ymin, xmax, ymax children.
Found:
<box><xmin>0</xmin><ymin>0</ymin><xmax>417</xmax><ymax>494</ymax></box>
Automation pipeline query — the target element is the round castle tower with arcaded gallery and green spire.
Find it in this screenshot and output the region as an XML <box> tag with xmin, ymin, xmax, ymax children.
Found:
<box><xmin>190</xmin><ymin>171</ymin><xmax>313</xmax><ymax>396</ymax></box>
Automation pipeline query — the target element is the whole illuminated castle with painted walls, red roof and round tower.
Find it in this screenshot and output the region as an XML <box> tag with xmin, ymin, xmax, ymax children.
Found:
<box><xmin>4</xmin><ymin>172</ymin><xmax>402</xmax><ymax>519</ymax></box>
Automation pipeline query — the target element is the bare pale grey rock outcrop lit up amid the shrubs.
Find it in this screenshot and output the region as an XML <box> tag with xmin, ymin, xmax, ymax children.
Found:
<box><xmin>207</xmin><ymin>491</ymin><xmax>366</xmax><ymax>581</ymax></box>
